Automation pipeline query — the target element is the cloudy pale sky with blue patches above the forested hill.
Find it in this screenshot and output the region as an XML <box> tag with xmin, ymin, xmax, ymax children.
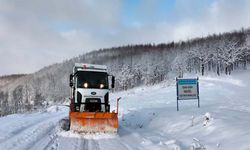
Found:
<box><xmin>0</xmin><ymin>0</ymin><xmax>250</xmax><ymax>75</ymax></box>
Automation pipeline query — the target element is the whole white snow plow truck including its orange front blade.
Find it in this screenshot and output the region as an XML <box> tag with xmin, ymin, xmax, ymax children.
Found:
<box><xmin>69</xmin><ymin>63</ymin><xmax>118</xmax><ymax>133</ymax></box>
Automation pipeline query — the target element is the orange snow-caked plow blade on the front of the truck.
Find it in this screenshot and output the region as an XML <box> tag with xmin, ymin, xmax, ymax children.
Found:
<box><xmin>69</xmin><ymin>112</ymin><xmax>118</xmax><ymax>133</ymax></box>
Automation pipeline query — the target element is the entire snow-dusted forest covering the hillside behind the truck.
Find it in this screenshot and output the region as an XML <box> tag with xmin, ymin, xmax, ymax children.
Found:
<box><xmin>0</xmin><ymin>29</ymin><xmax>250</xmax><ymax>116</ymax></box>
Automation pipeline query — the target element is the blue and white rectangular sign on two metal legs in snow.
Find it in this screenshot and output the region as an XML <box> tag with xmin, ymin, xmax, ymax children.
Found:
<box><xmin>176</xmin><ymin>78</ymin><xmax>200</xmax><ymax>111</ymax></box>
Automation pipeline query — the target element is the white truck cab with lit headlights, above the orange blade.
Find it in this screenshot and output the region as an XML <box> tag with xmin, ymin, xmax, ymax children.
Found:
<box><xmin>70</xmin><ymin>63</ymin><xmax>115</xmax><ymax>112</ymax></box>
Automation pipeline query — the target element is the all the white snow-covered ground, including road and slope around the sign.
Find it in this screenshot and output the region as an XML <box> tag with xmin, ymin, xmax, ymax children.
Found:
<box><xmin>0</xmin><ymin>71</ymin><xmax>250</xmax><ymax>150</ymax></box>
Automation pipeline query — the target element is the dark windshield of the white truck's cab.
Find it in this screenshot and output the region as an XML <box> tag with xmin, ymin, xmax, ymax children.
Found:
<box><xmin>76</xmin><ymin>71</ymin><xmax>108</xmax><ymax>89</ymax></box>
